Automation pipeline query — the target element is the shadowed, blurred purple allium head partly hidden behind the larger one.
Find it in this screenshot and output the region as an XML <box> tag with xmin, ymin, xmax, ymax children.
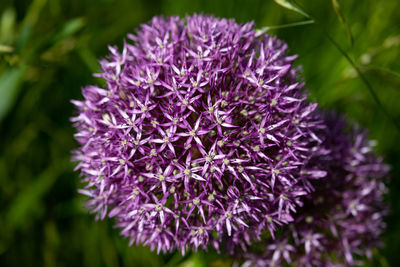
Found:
<box><xmin>244</xmin><ymin>115</ymin><xmax>388</xmax><ymax>266</ymax></box>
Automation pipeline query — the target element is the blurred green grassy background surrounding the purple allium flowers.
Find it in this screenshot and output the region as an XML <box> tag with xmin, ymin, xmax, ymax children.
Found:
<box><xmin>0</xmin><ymin>0</ymin><xmax>400</xmax><ymax>266</ymax></box>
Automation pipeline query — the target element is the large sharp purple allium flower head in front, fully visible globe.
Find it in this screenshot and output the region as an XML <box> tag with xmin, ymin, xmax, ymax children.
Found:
<box><xmin>73</xmin><ymin>15</ymin><xmax>325</xmax><ymax>253</ymax></box>
